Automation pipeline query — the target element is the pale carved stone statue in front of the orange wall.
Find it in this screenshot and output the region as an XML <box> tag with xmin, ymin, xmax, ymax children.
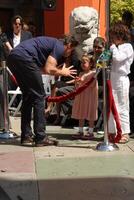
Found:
<box><xmin>70</xmin><ymin>6</ymin><xmax>98</xmax><ymax>59</ymax></box>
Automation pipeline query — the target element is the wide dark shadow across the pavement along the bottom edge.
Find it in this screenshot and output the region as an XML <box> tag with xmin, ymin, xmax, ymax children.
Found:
<box><xmin>0</xmin><ymin>177</ymin><xmax>134</xmax><ymax>200</ymax></box>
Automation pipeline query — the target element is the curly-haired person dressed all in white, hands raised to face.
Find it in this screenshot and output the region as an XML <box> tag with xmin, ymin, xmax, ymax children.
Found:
<box><xmin>108</xmin><ymin>21</ymin><xmax>134</xmax><ymax>144</ymax></box>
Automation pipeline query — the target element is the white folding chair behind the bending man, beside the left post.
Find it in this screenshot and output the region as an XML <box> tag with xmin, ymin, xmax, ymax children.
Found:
<box><xmin>8</xmin><ymin>87</ymin><xmax>22</xmax><ymax>117</ymax></box>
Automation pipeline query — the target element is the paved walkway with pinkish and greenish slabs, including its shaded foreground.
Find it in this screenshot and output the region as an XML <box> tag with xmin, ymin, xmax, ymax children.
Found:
<box><xmin>0</xmin><ymin>117</ymin><xmax>134</xmax><ymax>200</ymax></box>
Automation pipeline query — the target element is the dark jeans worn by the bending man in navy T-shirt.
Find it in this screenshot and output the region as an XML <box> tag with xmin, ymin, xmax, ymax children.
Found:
<box><xmin>8</xmin><ymin>54</ymin><xmax>46</xmax><ymax>141</ymax></box>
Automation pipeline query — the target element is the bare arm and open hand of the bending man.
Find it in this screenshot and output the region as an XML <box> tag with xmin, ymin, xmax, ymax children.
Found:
<box><xmin>43</xmin><ymin>56</ymin><xmax>77</xmax><ymax>78</ymax></box>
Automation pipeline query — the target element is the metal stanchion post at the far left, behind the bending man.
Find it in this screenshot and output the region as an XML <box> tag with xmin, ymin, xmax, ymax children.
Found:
<box><xmin>0</xmin><ymin>61</ymin><xmax>13</xmax><ymax>139</ymax></box>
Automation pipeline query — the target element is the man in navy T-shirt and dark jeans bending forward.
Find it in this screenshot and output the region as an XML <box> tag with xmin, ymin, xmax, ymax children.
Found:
<box><xmin>8</xmin><ymin>36</ymin><xmax>78</xmax><ymax>146</ymax></box>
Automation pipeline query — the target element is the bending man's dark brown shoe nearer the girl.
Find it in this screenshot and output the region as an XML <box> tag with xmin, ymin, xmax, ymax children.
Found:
<box><xmin>35</xmin><ymin>137</ymin><xmax>58</xmax><ymax>147</ymax></box>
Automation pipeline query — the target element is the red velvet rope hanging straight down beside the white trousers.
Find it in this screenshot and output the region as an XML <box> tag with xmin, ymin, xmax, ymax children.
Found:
<box><xmin>107</xmin><ymin>80</ymin><xmax>122</xmax><ymax>143</ymax></box>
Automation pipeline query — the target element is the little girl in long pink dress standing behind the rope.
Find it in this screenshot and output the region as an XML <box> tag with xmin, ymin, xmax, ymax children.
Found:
<box><xmin>72</xmin><ymin>54</ymin><xmax>98</xmax><ymax>139</ymax></box>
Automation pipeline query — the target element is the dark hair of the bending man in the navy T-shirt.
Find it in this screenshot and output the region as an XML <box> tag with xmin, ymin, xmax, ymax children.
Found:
<box><xmin>62</xmin><ymin>35</ymin><xmax>79</xmax><ymax>47</ymax></box>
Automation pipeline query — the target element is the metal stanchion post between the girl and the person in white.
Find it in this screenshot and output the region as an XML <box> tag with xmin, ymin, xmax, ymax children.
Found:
<box><xmin>96</xmin><ymin>67</ymin><xmax>119</xmax><ymax>151</ymax></box>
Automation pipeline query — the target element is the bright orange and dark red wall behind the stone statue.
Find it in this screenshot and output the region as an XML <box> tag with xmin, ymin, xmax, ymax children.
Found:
<box><xmin>44</xmin><ymin>0</ymin><xmax>107</xmax><ymax>38</ymax></box>
